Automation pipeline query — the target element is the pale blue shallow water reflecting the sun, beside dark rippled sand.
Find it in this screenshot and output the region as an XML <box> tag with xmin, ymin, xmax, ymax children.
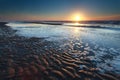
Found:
<box><xmin>7</xmin><ymin>22</ymin><xmax>120</xmax><ymax>73</ymax></box>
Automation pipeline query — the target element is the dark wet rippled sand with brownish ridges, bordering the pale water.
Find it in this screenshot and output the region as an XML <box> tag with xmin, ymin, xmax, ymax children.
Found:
<box><xmin>0</xmin><ymin>23</ymin><xmax>120</xmax><ymax>80</ymax></box>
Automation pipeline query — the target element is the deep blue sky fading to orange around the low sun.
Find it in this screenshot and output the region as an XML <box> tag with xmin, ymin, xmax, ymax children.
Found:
<box><xmin>0</xmin><ymin>0</ymin><xmax>120</xmax><ymax>21</ymax></box>
